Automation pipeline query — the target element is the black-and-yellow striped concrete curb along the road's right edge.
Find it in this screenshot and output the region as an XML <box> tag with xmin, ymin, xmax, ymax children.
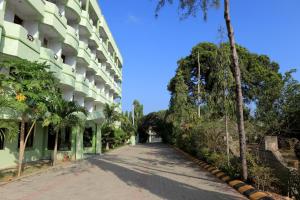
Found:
<box><xmin>173</xmin><ymin>147</ymin><xmax>274</xmax><ymax>200</ymax></box>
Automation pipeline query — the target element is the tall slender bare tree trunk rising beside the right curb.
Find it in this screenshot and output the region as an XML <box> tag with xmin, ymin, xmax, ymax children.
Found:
<box><xmin>224</xmin><ymin>0</ymin><xmax>248</xmax><ymax>180</ymax></box>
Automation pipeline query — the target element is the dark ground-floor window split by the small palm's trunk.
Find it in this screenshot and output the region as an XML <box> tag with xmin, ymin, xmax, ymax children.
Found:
<box><xmin>47</xmin><ymin>126</ymin><xmax>72</xmax><ymax>151</ymax></box>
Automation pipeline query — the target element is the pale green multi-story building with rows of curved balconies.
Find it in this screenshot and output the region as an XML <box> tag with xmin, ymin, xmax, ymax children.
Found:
<box><xmin>0</xmin><ymin>0</ymin><xmax>123</xmax><ymax>169</ymax></box>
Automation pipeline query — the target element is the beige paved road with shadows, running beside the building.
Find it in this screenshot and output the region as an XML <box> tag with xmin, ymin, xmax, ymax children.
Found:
<box><xmin>0</xmin><ymin>144</ymin><xmax>245</xmax><ymax>200</ymax></box>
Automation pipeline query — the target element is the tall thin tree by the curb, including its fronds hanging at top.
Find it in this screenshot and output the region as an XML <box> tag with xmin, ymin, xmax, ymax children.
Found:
<box><xmin>156</xmin><ymin>0</ymin><xmax>248</xmax><ymax>180</ymax></box>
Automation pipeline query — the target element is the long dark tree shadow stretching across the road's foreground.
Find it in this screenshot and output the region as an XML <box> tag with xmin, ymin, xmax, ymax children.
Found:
<box><xmin>88</xmin><ymin>158</ymin><xmax>241</xmax><ymax>200</ymax></box>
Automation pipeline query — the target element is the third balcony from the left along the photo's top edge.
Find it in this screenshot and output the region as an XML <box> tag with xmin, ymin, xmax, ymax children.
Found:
<box><xmin>65</xmin><ymin>0</ymin><xmax>81</xmax><ymax>24</ymax></box>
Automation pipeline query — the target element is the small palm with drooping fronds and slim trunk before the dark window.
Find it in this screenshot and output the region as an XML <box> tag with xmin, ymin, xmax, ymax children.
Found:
<box><xmin>43</xmin><ymin>96</ymin><xmax>88</xmax><ymax>165</ymax></box>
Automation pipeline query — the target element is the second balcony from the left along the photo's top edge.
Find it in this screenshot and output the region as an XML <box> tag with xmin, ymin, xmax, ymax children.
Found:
<box><xmin>40</xmin><ymin>1</ymin><xmax>67</xmax><ymax>41</ymax></box>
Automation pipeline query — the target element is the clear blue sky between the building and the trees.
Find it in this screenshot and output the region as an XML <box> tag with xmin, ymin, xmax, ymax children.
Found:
<box><xmin>99</xmin><ymin>0</ymin><xmax>300</xmax><ymax>113</ymax></box>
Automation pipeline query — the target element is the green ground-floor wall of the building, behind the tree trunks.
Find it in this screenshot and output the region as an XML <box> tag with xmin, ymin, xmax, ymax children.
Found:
<box><xmin>0</xmin><ymin>123</ymin><xmax>101</xmax><ymax>169</ymax></box>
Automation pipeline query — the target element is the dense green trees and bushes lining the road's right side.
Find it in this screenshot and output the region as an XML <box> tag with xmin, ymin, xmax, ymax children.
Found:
<box><xmin>140</xmin><ymin>43</ymin><xmax>300</xmax><ymax>197</ymax></box>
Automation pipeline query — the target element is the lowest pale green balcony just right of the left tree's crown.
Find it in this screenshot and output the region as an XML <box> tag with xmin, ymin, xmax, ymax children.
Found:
<box><xmin>60</xmin><ymin>64</ymin><xmax>76</xmax><ymax>89</ymax></box>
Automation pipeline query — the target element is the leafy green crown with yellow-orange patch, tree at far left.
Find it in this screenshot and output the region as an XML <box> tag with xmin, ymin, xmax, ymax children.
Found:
<box><xmin>0</xmin><ymin>59</ymin><xmax>59</xmax><ymax>144</ymax></box>
